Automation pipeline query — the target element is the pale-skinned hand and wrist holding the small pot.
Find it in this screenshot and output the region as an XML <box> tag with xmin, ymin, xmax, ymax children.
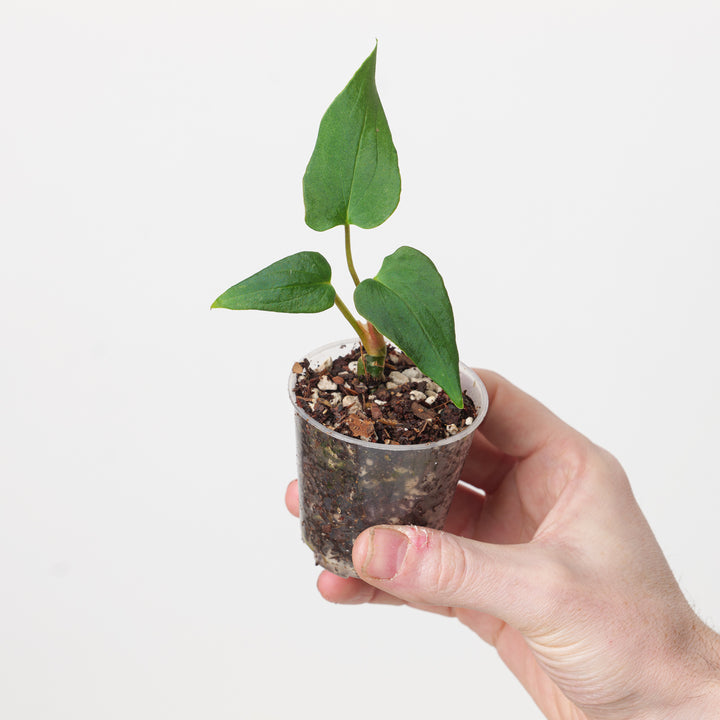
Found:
<box><xmin>286</xmin><ymin>371</ymin><xmax>720</xmax><ymax>720</ymax></box>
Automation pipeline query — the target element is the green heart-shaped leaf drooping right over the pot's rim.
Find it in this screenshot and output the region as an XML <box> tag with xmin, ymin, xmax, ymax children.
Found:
<box><xmin>354</xmin><ymin>247</ymin><xmax>463</xmax><ymax>407</ymax></box>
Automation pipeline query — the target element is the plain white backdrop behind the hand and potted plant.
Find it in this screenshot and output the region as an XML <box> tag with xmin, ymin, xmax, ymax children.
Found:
<box><xmin>0</xmin><ymin>0</ymin><xmax>720</xmax><ymax>720</ymax></box>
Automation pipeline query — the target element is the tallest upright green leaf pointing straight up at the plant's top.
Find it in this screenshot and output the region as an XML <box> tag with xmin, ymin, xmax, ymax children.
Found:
<box><xmin>303</xmin><ymin>44</ymin><xmax>400</xmax><ymax>231</ymax></box>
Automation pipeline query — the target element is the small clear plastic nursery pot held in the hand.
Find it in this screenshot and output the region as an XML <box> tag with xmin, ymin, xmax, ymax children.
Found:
<box><xmin>289</xmin><ymin>340</ymin><xmax>488</xmax><ymax>577</ymax></box>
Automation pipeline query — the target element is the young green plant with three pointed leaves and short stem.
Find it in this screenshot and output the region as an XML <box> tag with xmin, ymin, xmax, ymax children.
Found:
<box><xmin>212</xmin><ymin>44</ymin><xmax>463</xmax><ymax>408</ymax></box>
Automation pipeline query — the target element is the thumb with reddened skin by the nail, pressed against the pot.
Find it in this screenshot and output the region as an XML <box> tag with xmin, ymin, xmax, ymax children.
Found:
<box><xmin>353</xmin><ymin>525</ymin><xmax>559</xmax><ymax>629</ymax></box>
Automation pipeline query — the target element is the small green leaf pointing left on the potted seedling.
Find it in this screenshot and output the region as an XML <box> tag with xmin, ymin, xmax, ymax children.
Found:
<box><xmin>212</xmin><ymin>252</ymin><xmax>335</xmax><ymax>313</ymax></box>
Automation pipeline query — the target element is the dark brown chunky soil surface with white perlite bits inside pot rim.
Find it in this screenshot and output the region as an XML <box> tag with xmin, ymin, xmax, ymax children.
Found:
<box><xmin>293</xmin><ymin>346</ymin><xmax>477</xmax><ymax>445</ymax></box>
